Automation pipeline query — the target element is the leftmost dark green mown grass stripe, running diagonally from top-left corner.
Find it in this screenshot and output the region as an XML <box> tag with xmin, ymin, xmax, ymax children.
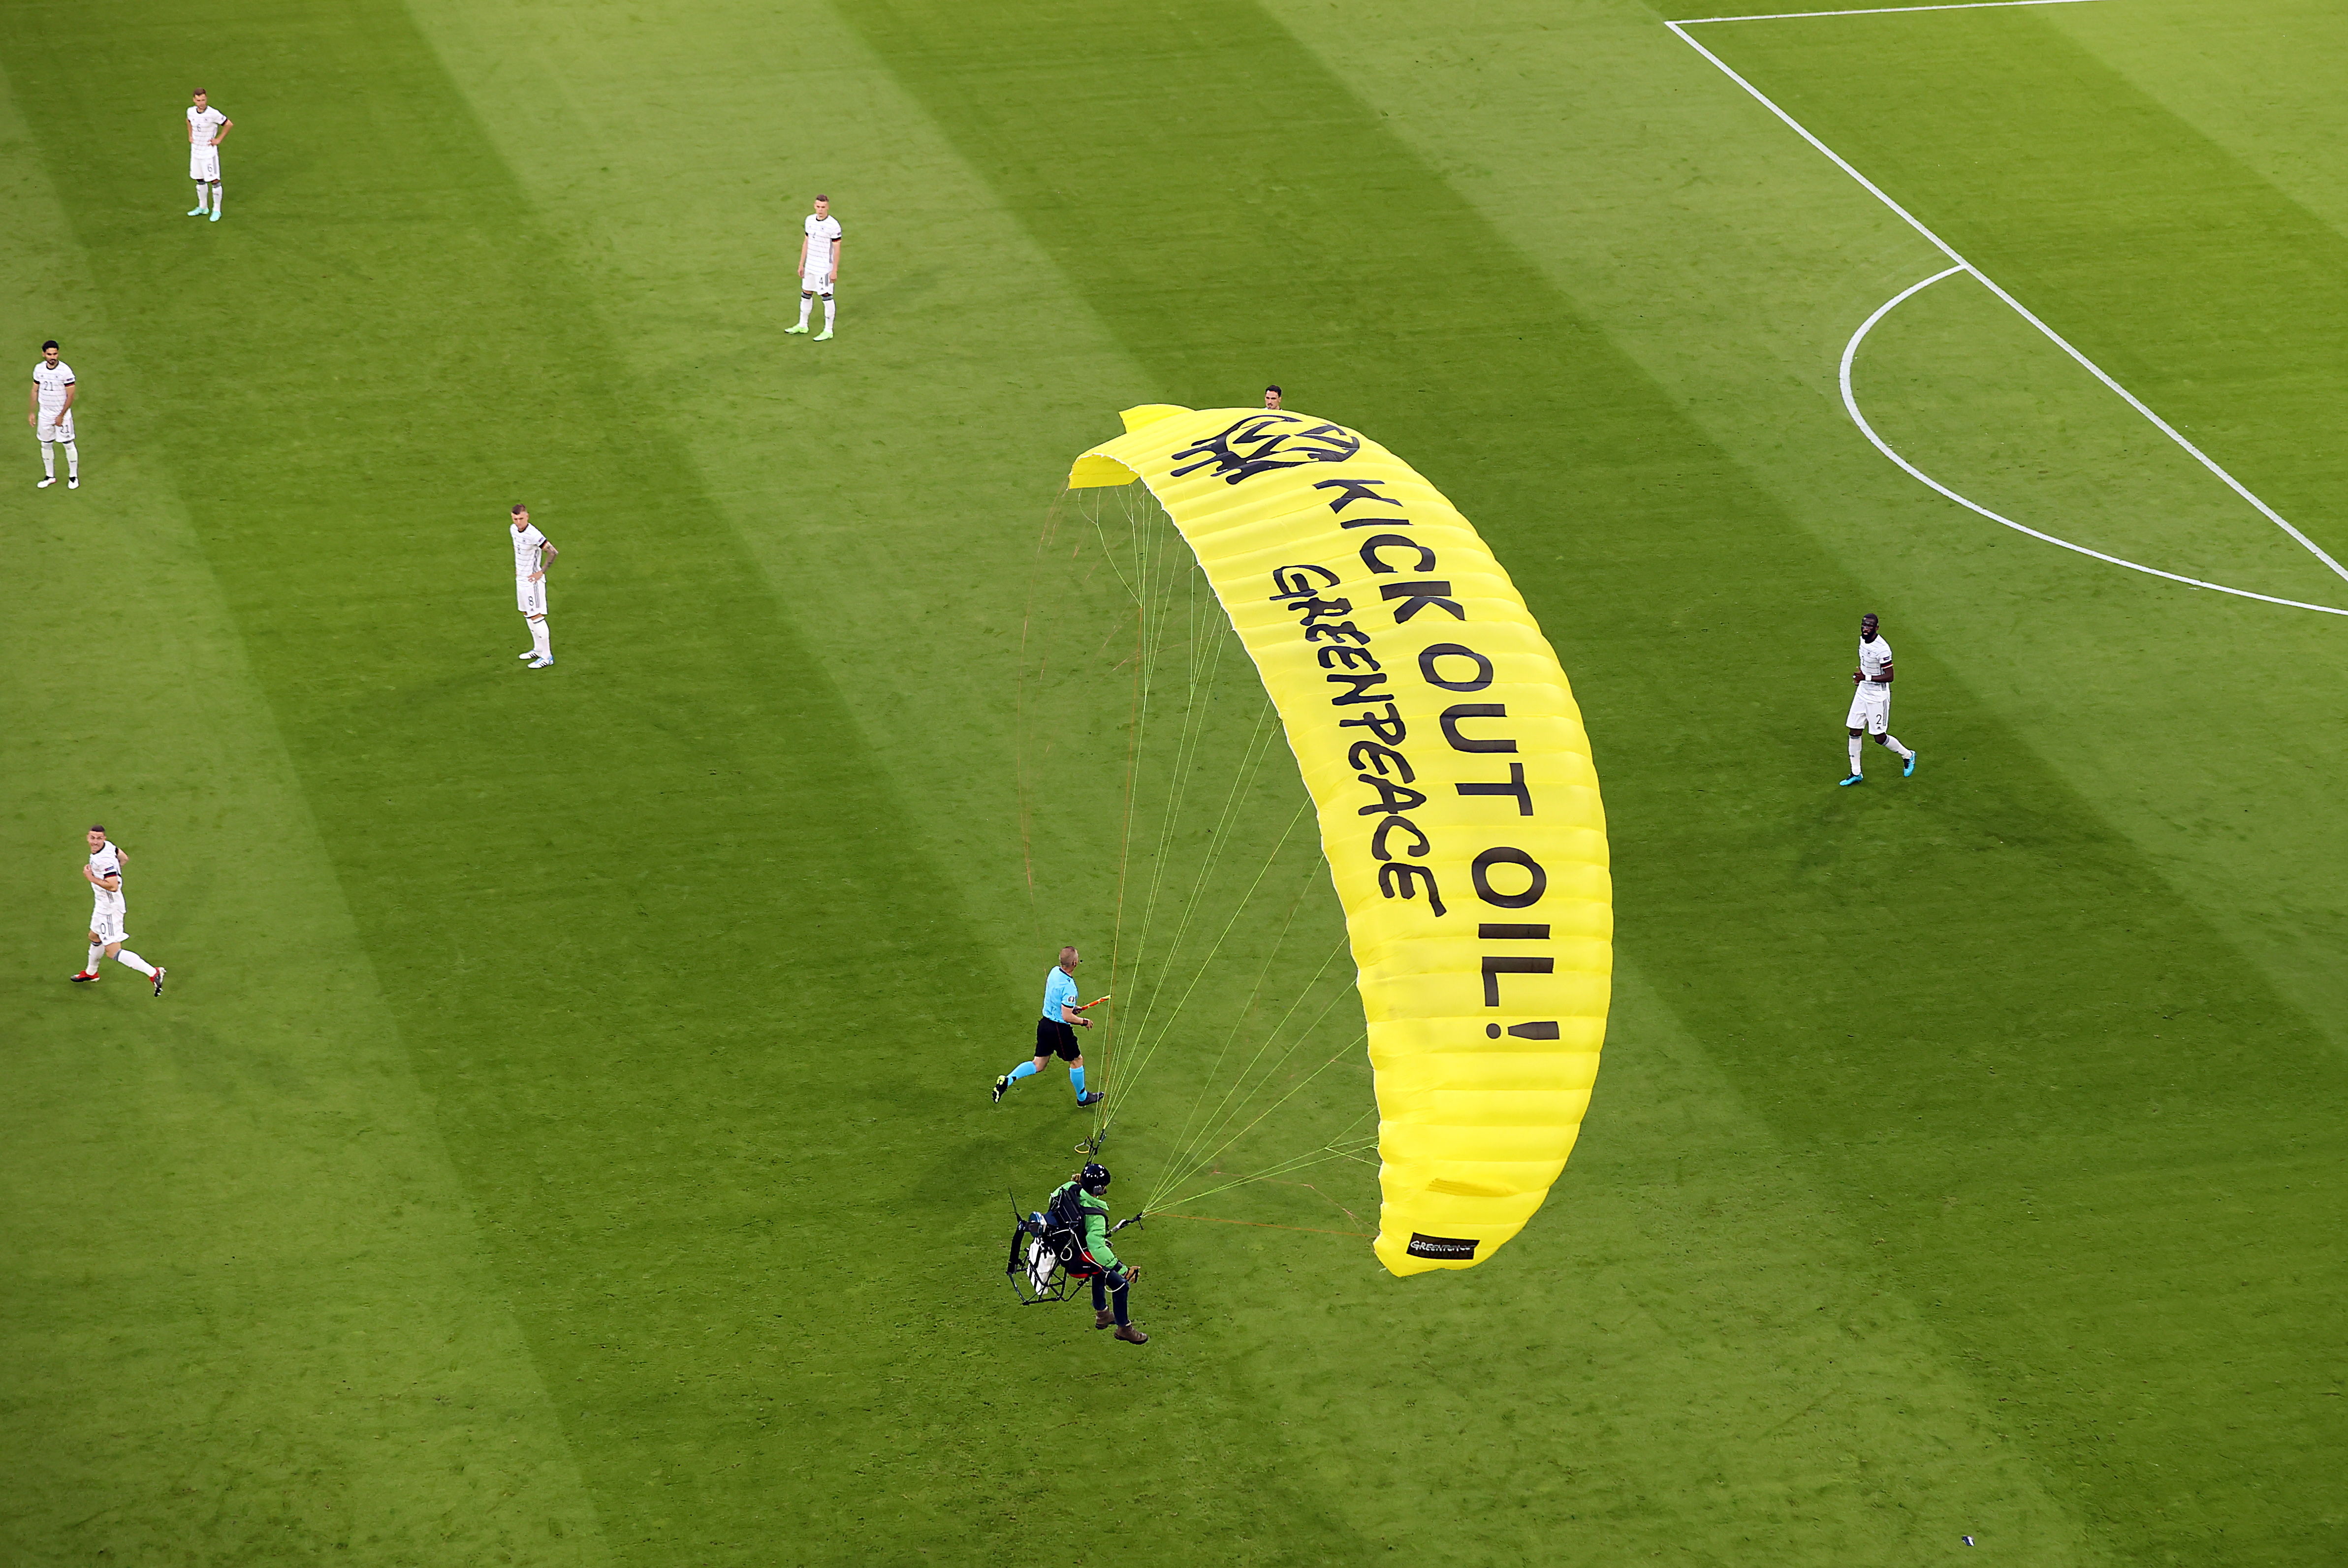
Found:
<box><xmin>0</xmin><ymin>7</ymin><xmax>1141</xmax><ymax>1561</ymax></box>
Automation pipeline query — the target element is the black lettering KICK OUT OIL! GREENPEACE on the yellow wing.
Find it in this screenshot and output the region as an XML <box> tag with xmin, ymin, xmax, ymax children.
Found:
<box><xmin>1270</xmin><ymin>479</ymin><xmax>1552</xmax><ymax>925</ymax></box>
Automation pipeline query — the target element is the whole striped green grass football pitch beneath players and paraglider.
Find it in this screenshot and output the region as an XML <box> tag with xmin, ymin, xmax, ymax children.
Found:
<box><xmin>0</xmin><ymin>0</ymin><xmax>2348</xmax><ymax>1568</ymax></box>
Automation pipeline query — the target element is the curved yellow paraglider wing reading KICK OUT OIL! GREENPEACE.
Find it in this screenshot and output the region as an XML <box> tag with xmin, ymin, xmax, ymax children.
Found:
<box><xmin>1068</xmin><ymin>404</ymin><xmax>1613</xmax><ymax>1275</ymax></box>
